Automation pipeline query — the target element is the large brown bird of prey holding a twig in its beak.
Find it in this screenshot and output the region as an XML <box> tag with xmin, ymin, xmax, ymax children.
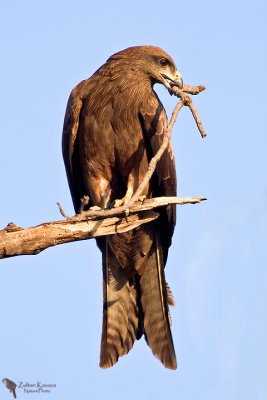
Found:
<box><xmin>62</xmin><ymin>46</ymin><xmax>183</xmax><ymax>369</ymax></box>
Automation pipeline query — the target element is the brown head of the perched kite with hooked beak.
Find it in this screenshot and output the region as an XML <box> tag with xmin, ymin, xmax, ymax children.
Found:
<box><xmin>109</xmin><ymin>46</ymin><xmax>183</xmax><ymax>89</ymax></box>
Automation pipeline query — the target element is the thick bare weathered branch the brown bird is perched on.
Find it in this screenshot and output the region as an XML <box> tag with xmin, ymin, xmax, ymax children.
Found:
<box><xmin>0</xmin><ymin>197</ymin><xmax>206</xmax><ymax>259</ymax></box>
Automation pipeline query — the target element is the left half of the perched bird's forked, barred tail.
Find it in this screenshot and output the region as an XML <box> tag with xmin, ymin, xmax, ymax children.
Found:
<box><xmin>100</xmin><ymin>240</ymin><xmax>138</xmax><ymax>368</ymax></box>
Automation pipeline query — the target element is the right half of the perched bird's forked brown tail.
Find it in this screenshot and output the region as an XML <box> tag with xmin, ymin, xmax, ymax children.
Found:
<box><xmin>140</xmin><ymin>234</ymin><xmax>177</xmax><ymax>369</ymax></box>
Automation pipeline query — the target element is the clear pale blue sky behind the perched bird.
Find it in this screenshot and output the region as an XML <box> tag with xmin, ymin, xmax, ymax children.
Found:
<box><xmin>0</xmin><ymin>0</ymin><xmax>267</xmax><ymax>400</ymax></box>
